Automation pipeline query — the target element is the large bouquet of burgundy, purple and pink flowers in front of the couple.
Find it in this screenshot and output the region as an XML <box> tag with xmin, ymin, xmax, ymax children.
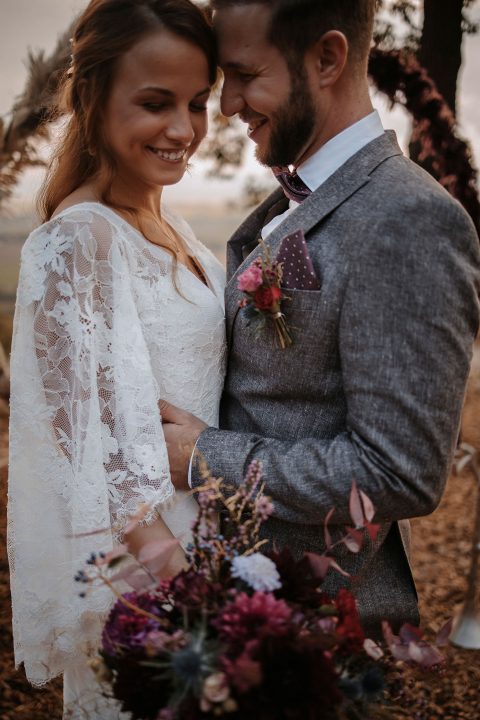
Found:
<box><xmin>77</xmin><ymin>462</ymin><xmax>450</xmax><ymax>720</ymax></box>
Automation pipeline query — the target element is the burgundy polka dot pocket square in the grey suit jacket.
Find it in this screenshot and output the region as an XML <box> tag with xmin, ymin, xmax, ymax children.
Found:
<box><xmin>276</xmin><ymin>230</ymin><xmax>320</xmax><ymax>290</ymax></box>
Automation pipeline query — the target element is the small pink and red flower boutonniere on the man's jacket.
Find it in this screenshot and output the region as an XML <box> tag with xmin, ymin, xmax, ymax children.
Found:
<box><xmin>237</xmin><ymin>242</ymin><xmax>293</xmax><ymax>349</ymax></box>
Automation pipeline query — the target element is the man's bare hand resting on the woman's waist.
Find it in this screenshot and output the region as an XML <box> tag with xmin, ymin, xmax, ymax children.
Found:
<box><xmin>158</xmin><ymin>400</ymin><xmax>208</xmax><ymax>490</ymax></box>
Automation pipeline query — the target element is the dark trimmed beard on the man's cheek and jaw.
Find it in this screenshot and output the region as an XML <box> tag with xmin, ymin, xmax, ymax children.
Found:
<box><xmin>257</xmin><ymin>69</ymin><xmax>315</xmax><ymax>167</ymax></box>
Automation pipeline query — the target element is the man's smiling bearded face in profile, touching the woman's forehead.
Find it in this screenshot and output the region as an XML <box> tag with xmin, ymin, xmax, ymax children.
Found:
<box><xmin>215</xmin><ymin>4</ymin><xmax>316</xmax><ymax>167</ymax></box>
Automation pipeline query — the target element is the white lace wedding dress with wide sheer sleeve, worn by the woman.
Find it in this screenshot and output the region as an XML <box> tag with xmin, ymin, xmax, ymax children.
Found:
<box><xmin>8</xmin><ymin>203</ymin><xmax>225</xmax><ymax>720</ymax></box>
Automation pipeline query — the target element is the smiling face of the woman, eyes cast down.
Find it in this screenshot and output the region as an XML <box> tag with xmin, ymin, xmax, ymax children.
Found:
<box><xmin>103</xmin><ymin>30</ymin><xmax>210</xmax><ymax>190</ymax></box>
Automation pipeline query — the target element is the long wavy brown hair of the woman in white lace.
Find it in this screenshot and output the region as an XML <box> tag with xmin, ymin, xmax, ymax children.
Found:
<box><xmin>38</xmin><ymin>0</ymin><xmax>217</xmax><ymax>222</ymax></box>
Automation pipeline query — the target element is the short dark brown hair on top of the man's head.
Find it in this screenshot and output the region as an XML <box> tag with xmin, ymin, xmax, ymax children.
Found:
<box><xmin>210</xmin><ymin>0</ymin><xmax>377</xmax><ymax>67</ymax></box>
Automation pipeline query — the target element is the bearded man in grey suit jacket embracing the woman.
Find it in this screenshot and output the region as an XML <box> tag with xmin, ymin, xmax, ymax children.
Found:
<box><xmin>161</xmin><ymin>0</ymin><xmax>480</xmax><ymax>632</ymax></box>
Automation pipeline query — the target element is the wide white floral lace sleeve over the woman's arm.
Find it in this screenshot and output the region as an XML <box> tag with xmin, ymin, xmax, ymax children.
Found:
<box><xmin>8</xmin><ymin>210</ymin><xmax>174</xmax><ymax>685</ymax></box>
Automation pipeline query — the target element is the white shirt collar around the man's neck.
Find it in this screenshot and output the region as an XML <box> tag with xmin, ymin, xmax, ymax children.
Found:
<box><xmin>297</xmin><ymin>110</ymin><xmax>385</xmax><ymax>192</ymax></box>
